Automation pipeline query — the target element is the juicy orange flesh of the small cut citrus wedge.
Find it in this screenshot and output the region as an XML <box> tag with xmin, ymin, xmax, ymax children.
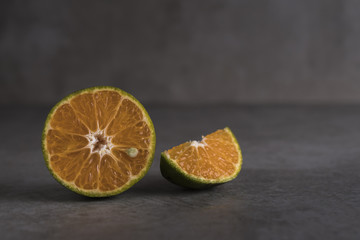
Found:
<box><xmin>167</xmin><ymin>129</ymin><xmax>239</xmax><ymax>180</ymax></box>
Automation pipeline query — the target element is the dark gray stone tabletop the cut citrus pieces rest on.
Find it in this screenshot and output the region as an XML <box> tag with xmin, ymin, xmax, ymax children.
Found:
<box><xmin>0</xmin><ymin>105</ymin><xmax>360</xmax><ymax>240</ymax></box>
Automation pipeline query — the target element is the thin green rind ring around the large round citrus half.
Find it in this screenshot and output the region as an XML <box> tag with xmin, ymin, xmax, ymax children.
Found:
<box><xmin>41</xmin><ymin>86</ymin><xmax>156</xmax><ymax>197</ymax></box>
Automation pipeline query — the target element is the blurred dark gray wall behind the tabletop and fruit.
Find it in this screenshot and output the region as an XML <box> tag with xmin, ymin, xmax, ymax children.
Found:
<box><xmin>0</xmin><ymin>0</ymin><xmax>360</xmax><ymax>104</ymax></box>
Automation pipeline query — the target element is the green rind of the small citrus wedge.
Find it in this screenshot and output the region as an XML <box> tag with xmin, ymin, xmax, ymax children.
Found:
<box><xmin>160</xmin><ymin>127</ymin><xmax>242</xmax><ymax>189</ymax></box>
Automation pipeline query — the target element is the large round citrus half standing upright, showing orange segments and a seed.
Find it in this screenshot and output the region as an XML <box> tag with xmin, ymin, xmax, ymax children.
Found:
<box><xmin>42</xmin><ymin>87</ymin><xmax>155</xmax><ymax>197</ymax></box>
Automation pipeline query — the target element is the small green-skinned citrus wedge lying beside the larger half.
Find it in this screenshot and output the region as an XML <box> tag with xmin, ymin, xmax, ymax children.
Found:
<box><xmin>160</xmin><ymin>127</ymin><xmax>242</xmax><ymax>188</ymax></box>
